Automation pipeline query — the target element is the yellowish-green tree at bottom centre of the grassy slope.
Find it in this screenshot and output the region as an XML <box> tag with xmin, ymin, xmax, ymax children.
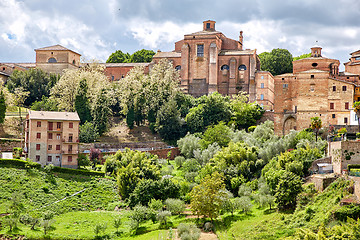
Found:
<box><xmin>190</xmin><ymin>172</ymin><xmax>225</xmax><ymax>221</ymax></box>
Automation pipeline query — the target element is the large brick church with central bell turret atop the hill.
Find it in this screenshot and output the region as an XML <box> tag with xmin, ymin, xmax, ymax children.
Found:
<box><xmin>152</xmin><ymin>20</ymin><xmax>274</xmax><ymax>110</ymax></box>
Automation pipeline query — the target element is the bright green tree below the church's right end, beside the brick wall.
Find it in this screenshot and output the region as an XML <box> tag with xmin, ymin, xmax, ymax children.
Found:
<box><xmin>230</xmin><ymin>94</ymin><xmax>265</xmax><ymax>129</ymax></box>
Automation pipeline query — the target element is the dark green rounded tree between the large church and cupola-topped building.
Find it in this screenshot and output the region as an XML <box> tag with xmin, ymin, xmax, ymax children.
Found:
<box><xmin>259</xmin><ymin>48</ymin><xmax>293</xmax><ymax>76</ymax></box>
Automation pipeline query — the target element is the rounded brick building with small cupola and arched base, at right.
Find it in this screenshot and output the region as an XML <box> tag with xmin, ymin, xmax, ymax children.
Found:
<box><xmin>274</xmin><ymin>46</ymin><xmax>356</xmax><ymax>135</ymax></box>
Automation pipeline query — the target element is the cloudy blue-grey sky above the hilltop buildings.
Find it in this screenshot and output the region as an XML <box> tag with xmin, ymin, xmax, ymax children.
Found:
<box><xmin>0</xmin><ymin>0</ymin><xmax>360</xmax><ymax>70</ymax></box>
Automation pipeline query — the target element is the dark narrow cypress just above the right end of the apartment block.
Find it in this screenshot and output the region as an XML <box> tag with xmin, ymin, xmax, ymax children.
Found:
<box><xmin>75</xmin><ymin>78</ymin><xmax>92</xmax><ymax>124</ymax></box>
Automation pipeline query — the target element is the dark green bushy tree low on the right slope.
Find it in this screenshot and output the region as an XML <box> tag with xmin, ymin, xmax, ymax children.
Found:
<box><xmin>275</xmin><ymin>171</ymin><xmax>302</xmax><ymax>209</ymax></box>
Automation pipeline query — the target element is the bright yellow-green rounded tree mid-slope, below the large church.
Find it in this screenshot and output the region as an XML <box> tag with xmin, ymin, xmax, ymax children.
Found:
<box><xmin>200</xmin><ymin>122</ymin><xmax>231</xmax><ymax>149</ymax></box>
